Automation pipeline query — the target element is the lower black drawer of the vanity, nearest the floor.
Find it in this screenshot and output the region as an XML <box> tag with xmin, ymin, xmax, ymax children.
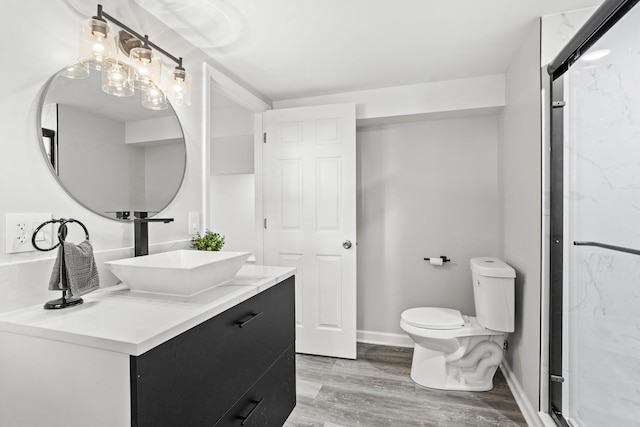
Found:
<box><xmin>215</xmin><ymin>345</ymin><xmax>296</xmax><ymax>427</ymax></box>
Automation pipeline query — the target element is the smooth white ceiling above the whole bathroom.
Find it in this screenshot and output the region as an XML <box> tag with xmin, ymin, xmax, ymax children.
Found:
<box><xmin>135</xmin><ymin>0</ymin><xmax>602</xmax><ymax>101</ymax></box>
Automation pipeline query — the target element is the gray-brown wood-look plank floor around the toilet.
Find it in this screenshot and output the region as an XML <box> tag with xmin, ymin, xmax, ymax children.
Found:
<box><xmin>285</xmin><ymin>344</ymin><xmax>527</xmax><ymax>427</ymax></box>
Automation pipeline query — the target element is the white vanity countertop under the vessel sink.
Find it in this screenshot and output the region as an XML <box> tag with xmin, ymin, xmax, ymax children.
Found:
<box><xmin>0</xmin><ymin>264</ymin><xmax>296</xmax><ymax>356</ymax></box>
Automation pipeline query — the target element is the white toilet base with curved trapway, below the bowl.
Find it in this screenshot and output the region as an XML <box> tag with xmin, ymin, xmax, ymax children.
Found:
<box><xmin>411</xmin><ymin>336</ymin><xmax>504</xmax><ymax>391</ymax></box>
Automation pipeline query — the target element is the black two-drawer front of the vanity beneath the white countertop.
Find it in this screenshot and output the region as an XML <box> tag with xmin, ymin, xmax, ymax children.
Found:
<box><xmin>130</xmin><ymin>277</ymin><xmax>296</xmax><ymax>427</ymax></box>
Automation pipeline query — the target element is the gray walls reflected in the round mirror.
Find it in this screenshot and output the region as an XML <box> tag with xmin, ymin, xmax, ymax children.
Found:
<box><xmin>58</xmin><ymin>104</ymin><xmax>185</xmax><ymax>217</ymax></box>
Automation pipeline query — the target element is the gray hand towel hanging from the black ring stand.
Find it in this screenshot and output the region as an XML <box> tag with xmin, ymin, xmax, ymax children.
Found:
<box><xmin>49</xmin><ymin>240</ymin><xmax>100</xmax><ymax>297</ymax></box>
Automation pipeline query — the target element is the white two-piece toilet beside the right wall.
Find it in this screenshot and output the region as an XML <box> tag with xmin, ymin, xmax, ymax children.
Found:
<box><xmin>400</xmin><ymin>257</ymin><xmax>516</xmax><ymax>391</ymax></box>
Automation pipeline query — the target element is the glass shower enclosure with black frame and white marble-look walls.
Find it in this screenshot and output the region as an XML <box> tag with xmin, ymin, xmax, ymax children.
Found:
<box><xmin>549</xmin><ymin>0</ymin><xmax>640</xmax><ymax>427</ymax></box>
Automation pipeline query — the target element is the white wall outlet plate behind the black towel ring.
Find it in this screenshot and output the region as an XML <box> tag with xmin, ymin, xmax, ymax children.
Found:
<box><xmin>5</xmin><ymin>214</ymin><xmax>53</xmax><ymax>254</ymax></box>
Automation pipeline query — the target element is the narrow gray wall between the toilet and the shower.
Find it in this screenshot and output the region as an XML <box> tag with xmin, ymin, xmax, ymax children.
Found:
<box><xmin>499</xmin><ymin>21</ymin><xmax>542</xmax><ymax>410</ymax></box>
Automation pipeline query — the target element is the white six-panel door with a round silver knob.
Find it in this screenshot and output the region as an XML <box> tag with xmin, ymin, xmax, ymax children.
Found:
<box><xmin>263</xmin><ymin>104</ymin><xmax>357</xmax><ymax>359</ymax></box>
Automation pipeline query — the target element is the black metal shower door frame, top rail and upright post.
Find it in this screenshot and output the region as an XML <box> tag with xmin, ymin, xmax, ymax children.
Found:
<box><xmin>547</xmin><ymin>0</ymin><xmax>640</xmax><ymax>427</ymax></box>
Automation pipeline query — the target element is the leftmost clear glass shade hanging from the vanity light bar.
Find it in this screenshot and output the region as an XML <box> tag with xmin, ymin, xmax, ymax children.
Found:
<box><xmin>78</xmin><ymin>18</ymin><xmax>116</xmax><ymax>70</ymax></box>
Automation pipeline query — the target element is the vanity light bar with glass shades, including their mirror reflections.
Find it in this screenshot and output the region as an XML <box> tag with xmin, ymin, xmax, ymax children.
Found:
<box><xmin>72</xmin><ymin>4</ymin><xmax>191</xmax><ymax>110</ymax></box>
